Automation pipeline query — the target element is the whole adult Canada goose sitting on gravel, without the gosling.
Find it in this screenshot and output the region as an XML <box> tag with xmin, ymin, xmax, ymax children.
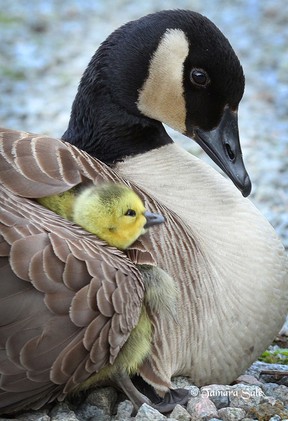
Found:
<box><xmin>0</xmin><ymin>10</ymin><xmax>288</xmax><ymax>413</ymax></box>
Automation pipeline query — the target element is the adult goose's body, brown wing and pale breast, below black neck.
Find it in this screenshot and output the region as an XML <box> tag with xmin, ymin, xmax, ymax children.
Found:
<box><xmin>0</xmin><ymin>130</ymin><xmax>288</xmax><ymax>410</ymax></box>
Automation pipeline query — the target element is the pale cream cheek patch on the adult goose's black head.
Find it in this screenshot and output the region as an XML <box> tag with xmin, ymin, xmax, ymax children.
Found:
<box><xmin>137</xmin><ymin>29</ymin><xmax>189</xmax><ymax>133</ymax></box>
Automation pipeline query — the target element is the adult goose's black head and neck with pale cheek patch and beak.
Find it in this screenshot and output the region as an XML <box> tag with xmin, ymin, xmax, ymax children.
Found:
<box><xmin>63</xmin><ymin>10</ymin><xmax>251</xmax><ymax>196</ymax></box>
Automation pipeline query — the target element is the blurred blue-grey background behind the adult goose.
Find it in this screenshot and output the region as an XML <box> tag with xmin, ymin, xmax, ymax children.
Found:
<box><xmin>0</xmin><ymin>0</ymin><xmax>288</xmax><ymax>248</ymax></box>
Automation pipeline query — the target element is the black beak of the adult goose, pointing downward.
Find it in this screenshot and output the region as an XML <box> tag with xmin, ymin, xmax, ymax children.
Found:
<box><xmin>194</xmin><ymin>107</ymin><xmax>252</xmax><ymax>197</ymax></box>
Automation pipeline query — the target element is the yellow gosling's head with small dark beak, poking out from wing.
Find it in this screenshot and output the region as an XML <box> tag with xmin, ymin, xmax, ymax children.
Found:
<box><xmin>72</xmin><ymin>184</ymin><xmax>164</xmax><ymax>250</ymax></box>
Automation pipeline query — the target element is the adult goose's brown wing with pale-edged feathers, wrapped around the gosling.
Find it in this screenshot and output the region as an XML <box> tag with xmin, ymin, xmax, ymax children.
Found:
<box><xmin>0</xmin><ymin>130</ymin><xmax>153</xmax><ymax>413</ymax></box>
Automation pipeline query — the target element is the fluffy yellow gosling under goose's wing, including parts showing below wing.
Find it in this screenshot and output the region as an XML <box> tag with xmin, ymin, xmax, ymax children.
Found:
<box><xmin>37</xmin><ymin>183</ymin><xmax>176</xmax><ymax>390</ymax></box>
